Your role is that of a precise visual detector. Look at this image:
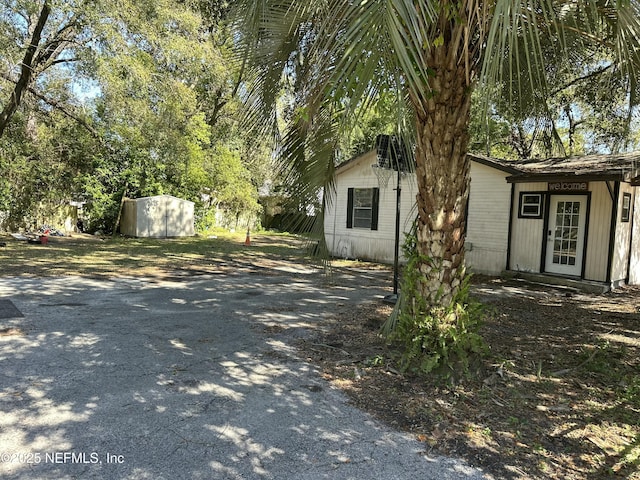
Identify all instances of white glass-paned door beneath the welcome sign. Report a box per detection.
[545,195,587,276]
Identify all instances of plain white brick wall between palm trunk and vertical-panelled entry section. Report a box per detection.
[465,161,511,275]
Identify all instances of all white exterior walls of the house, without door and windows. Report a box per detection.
[324,150,640,284]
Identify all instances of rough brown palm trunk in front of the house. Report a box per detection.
[414,25,471,307]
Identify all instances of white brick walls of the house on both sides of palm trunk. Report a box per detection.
[324,151,511,274]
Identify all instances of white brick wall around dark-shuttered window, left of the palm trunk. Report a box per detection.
[324,150,417,263]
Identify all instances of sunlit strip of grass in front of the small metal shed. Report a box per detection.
[0,231,308,276]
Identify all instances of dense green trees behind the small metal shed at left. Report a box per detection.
[0,0,271,231]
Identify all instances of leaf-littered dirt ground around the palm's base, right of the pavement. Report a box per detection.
[300,278,640,479]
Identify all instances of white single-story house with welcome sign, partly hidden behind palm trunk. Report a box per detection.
[324,146,640,288]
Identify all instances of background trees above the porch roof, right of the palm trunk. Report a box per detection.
[469,61,640,159]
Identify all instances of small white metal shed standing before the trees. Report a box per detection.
[120,195,195,238]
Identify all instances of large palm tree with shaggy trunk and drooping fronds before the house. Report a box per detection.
[233,0,640,378]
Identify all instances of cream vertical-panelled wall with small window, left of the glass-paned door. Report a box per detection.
[509,182,547,273]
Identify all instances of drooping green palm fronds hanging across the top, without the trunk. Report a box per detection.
[234,0,640,240]
